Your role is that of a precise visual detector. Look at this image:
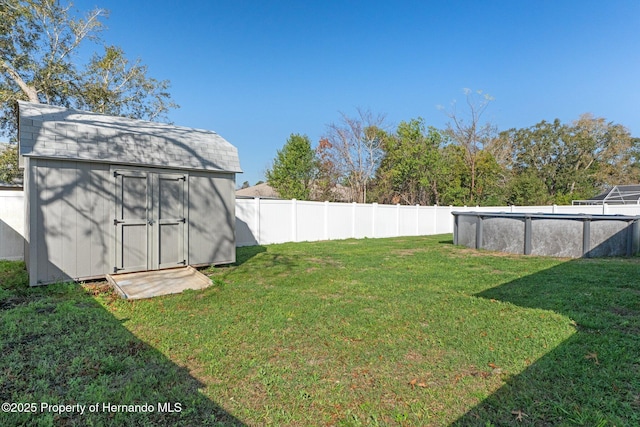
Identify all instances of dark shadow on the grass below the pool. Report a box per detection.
[453,258,640,426]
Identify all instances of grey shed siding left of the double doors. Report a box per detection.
[28,159,113,285]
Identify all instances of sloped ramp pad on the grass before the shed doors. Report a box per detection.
[107,266,211,299]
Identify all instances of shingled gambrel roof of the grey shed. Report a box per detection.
[18,101,242,172]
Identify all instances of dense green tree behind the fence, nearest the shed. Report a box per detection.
[266,134,316,200]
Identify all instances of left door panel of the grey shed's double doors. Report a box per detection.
[114,171,149,272]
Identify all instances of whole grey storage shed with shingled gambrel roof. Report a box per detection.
[19,102,242,286]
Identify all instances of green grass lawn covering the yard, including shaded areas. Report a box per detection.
[0,235,640,426]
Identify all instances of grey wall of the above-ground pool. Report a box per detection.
[452,212,640,258]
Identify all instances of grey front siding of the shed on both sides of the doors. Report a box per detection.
[25,158,235,285]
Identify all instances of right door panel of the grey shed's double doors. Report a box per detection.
[154,174,186,268]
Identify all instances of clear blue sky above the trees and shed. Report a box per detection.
[75,0,640,185]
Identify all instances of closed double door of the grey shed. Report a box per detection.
[113,170,188,273]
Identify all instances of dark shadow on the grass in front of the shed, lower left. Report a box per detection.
[0,261,243,426]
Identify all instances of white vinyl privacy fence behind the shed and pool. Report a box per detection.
[0,191,640,259]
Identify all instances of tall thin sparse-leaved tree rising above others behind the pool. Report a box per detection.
[446,89,497,204]
